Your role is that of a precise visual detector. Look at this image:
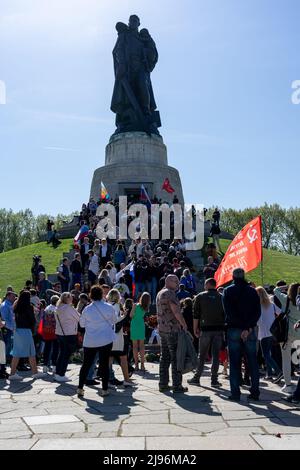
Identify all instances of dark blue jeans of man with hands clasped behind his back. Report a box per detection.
[227,328,259,399]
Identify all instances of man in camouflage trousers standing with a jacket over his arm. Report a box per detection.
[156,274,187,393]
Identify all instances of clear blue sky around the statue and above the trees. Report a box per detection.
[0,0,300,214]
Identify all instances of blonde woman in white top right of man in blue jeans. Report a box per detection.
[256,287,283,382]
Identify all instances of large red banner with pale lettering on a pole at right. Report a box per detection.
[215,216,262,287]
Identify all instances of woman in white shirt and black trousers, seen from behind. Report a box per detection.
[77,286,118,398]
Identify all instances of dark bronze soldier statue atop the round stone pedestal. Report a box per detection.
[111,15,161,135]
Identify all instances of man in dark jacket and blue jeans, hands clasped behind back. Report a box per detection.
[223,268,261,401]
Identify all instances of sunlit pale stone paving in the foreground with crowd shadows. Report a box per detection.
[0,364,300,450]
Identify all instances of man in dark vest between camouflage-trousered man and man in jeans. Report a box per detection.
[188,278,225,387]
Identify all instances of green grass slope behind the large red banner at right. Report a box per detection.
[214,240,300,285]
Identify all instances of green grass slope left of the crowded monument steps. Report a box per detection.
[0,239,72,297]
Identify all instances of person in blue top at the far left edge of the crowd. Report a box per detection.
[0,291,17,378]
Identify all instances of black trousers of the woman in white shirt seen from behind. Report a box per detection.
[79,343,112,390]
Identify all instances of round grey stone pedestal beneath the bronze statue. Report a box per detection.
[91,132,184,204]
